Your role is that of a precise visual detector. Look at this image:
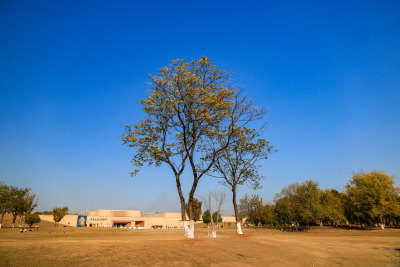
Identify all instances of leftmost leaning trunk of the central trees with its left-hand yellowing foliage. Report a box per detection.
[121,80,188,235]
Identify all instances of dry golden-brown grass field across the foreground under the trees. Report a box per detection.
[0,217,400,266]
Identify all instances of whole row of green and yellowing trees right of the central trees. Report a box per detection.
[239,171,400,229]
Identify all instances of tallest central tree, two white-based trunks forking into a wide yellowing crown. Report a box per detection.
[122,57,259,238]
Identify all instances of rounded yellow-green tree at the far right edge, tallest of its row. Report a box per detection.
[345,170,400,229]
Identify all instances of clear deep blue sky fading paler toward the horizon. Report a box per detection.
[0,1,400,215]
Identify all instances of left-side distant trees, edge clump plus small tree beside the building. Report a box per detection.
[0,181,68,228]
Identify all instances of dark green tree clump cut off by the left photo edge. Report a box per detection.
[0,181,40,228]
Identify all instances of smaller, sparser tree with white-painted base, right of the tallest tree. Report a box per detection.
[211,126,276,234]
